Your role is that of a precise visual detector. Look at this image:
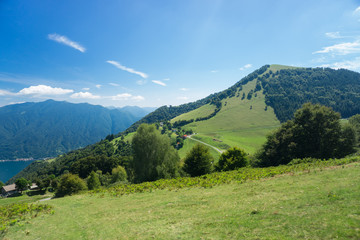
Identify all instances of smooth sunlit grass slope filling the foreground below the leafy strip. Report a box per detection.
[5,163,360,239]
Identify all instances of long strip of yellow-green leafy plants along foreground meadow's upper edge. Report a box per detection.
[90,156,360,196]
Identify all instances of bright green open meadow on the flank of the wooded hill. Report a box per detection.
[177,80,280,153]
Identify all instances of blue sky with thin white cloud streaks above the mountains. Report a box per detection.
[0,0,360,107]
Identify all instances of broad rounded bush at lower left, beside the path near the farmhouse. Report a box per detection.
[55,173,87,197]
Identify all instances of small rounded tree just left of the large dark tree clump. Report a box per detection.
[215,147,248,171]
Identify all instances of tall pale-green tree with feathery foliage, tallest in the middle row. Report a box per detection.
[132,124,179,182]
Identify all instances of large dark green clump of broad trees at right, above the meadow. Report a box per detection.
[258,103,354,166]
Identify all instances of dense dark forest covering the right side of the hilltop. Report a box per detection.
[259,68,360,122]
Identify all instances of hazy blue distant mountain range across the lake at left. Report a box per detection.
[0,100,154,159]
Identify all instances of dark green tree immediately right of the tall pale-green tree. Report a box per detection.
[183,144,213,177]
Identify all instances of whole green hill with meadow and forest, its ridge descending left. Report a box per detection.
[11,65,360,181]
